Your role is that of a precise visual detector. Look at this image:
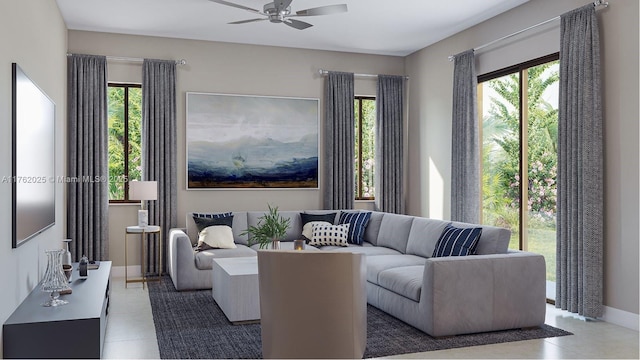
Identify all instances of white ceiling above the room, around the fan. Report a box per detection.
[56,0,528,56]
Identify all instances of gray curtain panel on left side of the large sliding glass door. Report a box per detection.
[451,50,480,223]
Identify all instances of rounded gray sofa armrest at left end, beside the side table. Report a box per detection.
[168,228,196,290]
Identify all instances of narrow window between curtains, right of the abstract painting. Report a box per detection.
[354,96,376,200]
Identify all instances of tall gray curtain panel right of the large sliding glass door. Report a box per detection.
[556,4,604,317]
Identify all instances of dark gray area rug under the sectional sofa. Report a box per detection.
[148,276,572,359]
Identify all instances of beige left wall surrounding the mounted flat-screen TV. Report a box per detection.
[0,0,67,356]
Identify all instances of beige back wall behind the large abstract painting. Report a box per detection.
[68,31,404,266]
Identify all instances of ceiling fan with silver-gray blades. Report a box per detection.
[209,0,347,30]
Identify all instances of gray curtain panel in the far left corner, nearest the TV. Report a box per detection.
[67,55,109,261]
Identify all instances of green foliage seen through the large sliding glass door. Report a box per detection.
[483,62,559,230]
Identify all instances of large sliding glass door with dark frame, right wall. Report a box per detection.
[478,54,559,290]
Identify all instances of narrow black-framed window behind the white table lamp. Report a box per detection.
[107,84,142,202]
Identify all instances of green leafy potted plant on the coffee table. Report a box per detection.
[242,205,290,249]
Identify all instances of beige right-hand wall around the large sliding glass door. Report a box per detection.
[406,0,640,318]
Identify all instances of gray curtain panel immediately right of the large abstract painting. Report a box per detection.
[323,72,355,210]
